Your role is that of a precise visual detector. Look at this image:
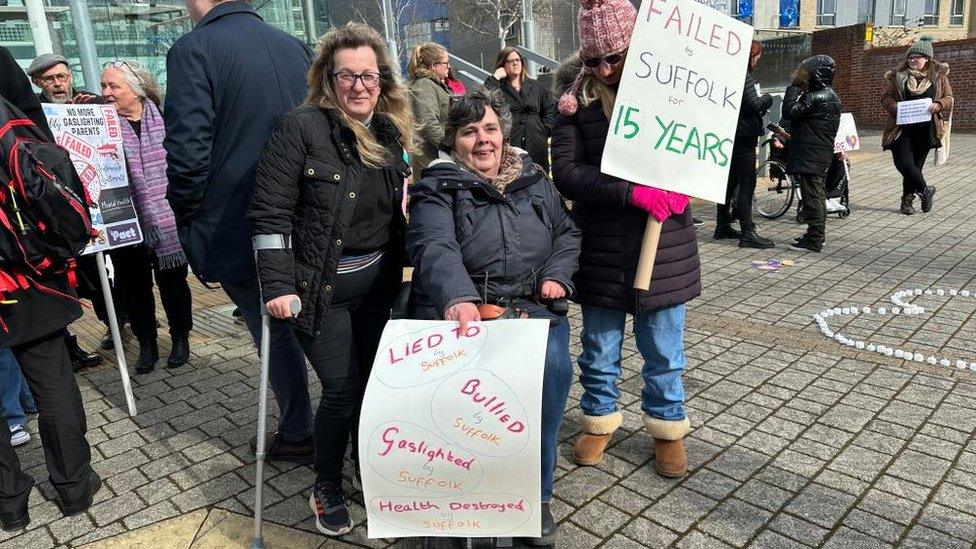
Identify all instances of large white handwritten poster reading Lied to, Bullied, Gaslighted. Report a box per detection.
[359,319,549,538]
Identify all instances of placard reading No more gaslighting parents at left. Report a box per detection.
[43,103,142,254]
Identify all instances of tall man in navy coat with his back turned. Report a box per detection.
[163,0,313,464]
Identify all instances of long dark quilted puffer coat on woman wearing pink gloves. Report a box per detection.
[552,57,701,313]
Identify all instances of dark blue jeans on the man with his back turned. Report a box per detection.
[221,273,312,442]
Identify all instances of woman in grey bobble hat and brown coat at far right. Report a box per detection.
[881,37,954,215]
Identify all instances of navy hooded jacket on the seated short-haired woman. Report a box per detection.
[407,155,580,318]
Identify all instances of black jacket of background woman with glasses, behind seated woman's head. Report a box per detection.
[485,76,556,172]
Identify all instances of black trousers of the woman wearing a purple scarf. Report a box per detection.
[111,246,193,341]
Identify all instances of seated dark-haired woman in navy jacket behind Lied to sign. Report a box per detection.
[407,91,580,545]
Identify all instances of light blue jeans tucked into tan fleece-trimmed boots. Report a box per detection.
[578,305,685,421]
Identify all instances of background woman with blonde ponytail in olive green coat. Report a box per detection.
[407,42,451,175]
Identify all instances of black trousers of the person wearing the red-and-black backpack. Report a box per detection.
[0,330,92,513]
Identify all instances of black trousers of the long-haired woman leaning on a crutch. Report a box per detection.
[295,252,402,484]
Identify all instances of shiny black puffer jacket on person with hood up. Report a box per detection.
[783,55,841,175]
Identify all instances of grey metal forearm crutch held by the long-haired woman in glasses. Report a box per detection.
[251,235,302,549]
